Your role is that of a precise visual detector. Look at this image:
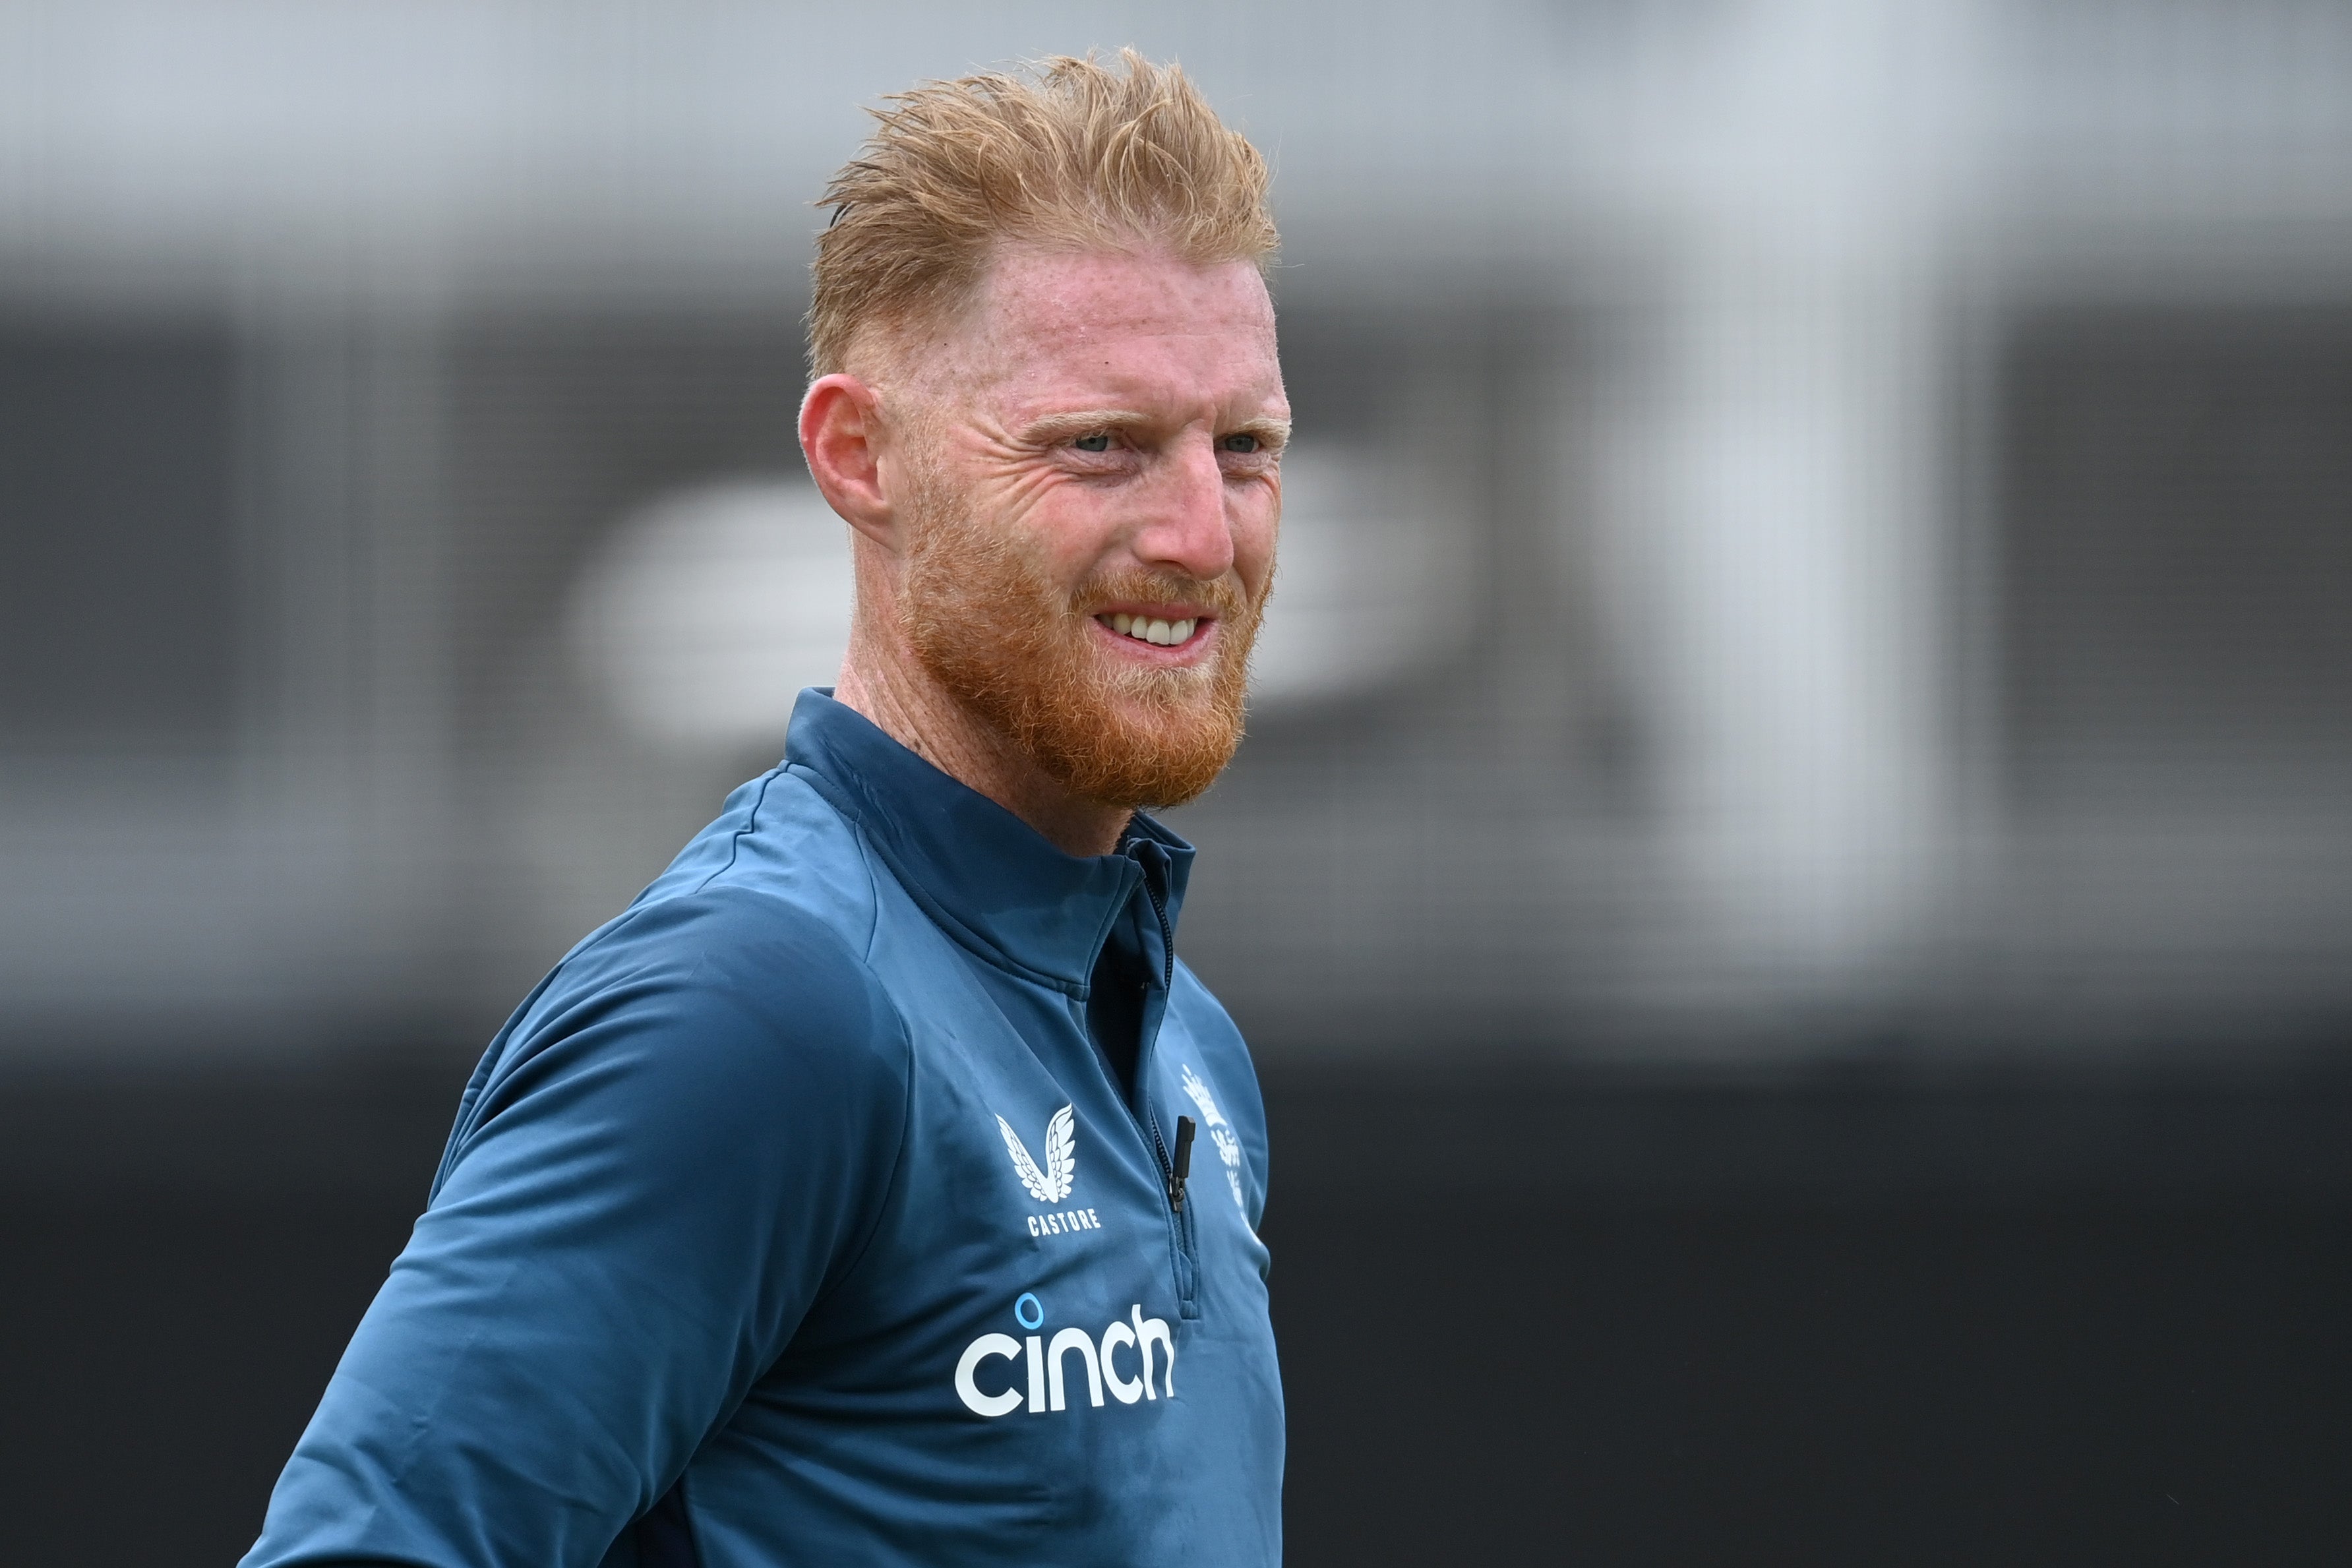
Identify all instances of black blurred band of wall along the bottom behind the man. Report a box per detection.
[0,1053,2352,1568]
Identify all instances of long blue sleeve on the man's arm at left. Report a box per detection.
[245,891,905,1568]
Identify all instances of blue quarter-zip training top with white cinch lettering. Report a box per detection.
[245,689,1282,1568]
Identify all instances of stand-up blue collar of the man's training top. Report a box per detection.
[783,686,1192,997]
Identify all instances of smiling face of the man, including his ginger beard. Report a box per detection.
[901,249,1289,806]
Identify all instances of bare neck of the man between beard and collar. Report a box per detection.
[833,637,1133,856]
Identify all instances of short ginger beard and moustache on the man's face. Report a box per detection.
[899,472,1273,808]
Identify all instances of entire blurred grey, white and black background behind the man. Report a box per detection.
[0,0,2352,1565]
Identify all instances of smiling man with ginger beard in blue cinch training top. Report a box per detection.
[245,54,1289,1568]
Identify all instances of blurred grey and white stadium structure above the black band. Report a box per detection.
[0,0,2352,1056]
